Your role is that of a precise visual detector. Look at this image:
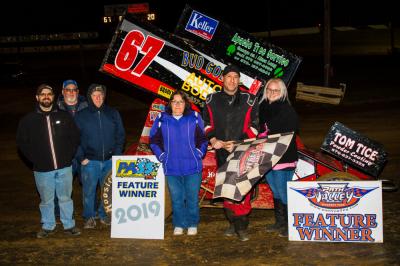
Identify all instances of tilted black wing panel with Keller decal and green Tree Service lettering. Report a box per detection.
[175,5,302,87]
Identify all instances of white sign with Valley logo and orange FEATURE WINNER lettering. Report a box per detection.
[287,181,383,243]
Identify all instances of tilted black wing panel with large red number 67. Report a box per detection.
[100,11,297,107]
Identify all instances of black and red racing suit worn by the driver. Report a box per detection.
[203,89,258,231]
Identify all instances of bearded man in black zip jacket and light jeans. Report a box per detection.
[17,84,80,238]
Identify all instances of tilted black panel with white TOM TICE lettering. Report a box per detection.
[321,122,387,177]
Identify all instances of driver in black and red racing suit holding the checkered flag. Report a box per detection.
[203,65,258,241]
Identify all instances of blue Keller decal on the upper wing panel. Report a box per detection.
[185,10,218,41]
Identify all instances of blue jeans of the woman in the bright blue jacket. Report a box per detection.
[167,173,201,228]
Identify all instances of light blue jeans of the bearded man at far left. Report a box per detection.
[33,166,75,230]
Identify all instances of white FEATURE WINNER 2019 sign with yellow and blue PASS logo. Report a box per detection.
[111,155,165,239]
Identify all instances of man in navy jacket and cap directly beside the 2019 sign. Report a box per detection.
[75,84,125,229]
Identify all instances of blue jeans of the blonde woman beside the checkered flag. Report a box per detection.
[265,170,294,205]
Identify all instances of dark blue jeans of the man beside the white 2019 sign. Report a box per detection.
[81,159,111,220]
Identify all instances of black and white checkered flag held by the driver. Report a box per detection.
[213,132,294,201]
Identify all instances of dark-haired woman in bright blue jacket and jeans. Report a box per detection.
[150,91,208,235]
